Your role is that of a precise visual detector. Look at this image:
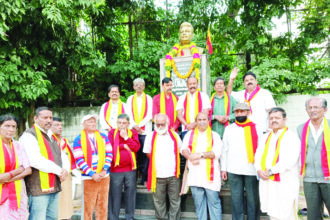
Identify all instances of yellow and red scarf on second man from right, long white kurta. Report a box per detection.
[261,126,288,182]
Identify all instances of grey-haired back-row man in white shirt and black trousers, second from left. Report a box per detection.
[126,78,152,185]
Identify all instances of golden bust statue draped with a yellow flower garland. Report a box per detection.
[165,22,203,81]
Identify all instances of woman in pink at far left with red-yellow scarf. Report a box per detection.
[0,114,32,220]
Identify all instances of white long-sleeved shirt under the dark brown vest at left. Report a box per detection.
[19,124,71,176]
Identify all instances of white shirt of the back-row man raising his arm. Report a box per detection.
[231,89,276,131]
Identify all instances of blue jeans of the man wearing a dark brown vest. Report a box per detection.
[29,192,60,220]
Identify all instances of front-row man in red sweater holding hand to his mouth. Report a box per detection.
[108,114,140,220]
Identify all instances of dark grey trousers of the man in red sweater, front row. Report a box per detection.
[108,170,136,220]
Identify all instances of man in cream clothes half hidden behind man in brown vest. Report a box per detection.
[51,117,76,219]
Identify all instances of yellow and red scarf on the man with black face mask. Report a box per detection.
[235,119,258,163]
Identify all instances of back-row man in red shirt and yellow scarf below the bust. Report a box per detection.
[152,77,180,131]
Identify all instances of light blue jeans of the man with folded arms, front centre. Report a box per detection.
[190,186,222,220]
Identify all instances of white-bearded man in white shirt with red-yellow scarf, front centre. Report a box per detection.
[143,113,182,220]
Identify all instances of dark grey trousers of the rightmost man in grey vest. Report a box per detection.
[304,182,330,220]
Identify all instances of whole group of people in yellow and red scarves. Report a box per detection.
[0,68,330,220]
